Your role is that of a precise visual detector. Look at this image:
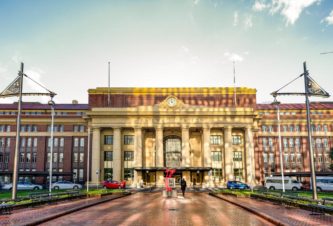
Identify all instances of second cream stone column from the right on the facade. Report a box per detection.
[224,126,234,181]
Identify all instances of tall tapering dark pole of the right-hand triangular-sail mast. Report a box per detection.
[303,62,318,200]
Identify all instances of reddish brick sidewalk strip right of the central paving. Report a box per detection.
[211,192,333,226]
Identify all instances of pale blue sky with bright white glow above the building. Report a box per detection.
[0,0,333,103]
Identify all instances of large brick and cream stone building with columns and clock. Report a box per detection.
[0,88,333,186]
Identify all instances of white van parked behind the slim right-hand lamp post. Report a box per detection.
[265,177,302,191]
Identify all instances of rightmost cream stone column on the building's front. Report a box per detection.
[245,126,255,184]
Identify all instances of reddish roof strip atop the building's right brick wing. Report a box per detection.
[257,102,333,110]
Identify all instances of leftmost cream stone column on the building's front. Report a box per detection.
[91,128,101,184]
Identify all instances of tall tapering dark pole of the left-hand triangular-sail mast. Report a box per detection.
[12,63,24,200]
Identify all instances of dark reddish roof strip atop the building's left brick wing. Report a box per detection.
[0,102,89,110]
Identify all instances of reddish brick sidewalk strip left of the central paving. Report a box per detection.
[0,194,128,226]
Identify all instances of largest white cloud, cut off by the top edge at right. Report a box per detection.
[252,0,321,26]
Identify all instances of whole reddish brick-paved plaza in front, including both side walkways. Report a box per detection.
[0,192,333,226]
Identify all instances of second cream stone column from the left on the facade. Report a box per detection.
[113,128,122,181]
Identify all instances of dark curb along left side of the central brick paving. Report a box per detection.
[18,193,131,226]
